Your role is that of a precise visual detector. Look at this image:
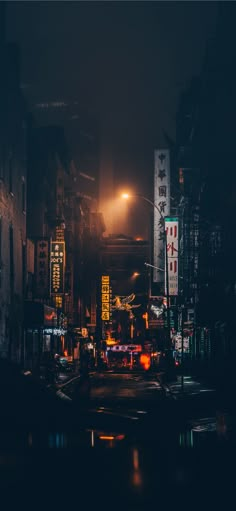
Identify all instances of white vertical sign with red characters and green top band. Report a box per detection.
[165,217,179,296]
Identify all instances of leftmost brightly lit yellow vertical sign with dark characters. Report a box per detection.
[50,241,65,294]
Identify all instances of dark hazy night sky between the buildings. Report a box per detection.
[7,1,218,234]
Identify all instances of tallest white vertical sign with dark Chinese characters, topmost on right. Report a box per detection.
[153,149,170,283]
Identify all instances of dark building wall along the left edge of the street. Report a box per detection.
[0,6,28,362]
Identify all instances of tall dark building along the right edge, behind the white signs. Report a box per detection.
[176,2,236,372]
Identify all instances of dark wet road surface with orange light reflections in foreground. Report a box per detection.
[0,373,235,511]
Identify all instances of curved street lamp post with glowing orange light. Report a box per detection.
[122,193,171,350]
